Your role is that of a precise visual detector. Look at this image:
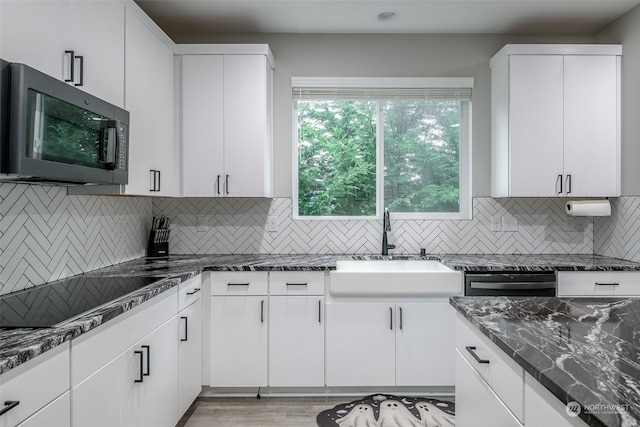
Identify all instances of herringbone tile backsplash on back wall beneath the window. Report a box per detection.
[153,198,593,254]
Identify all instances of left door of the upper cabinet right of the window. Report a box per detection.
[508,55,563,197]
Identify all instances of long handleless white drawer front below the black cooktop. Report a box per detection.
[71,286,178,387]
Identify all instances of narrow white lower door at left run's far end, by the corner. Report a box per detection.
[178,299,202,417]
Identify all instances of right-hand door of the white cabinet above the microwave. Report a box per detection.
[70,0,125,107]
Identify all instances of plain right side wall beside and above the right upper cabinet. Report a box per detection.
[595,6,640,196]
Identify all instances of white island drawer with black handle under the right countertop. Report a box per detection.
[456,313,524,422]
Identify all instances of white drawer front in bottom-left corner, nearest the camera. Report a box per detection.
[0,342,70,426]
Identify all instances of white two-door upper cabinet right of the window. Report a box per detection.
[491,45,622,197]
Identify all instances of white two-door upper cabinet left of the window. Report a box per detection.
[178,45,273,197]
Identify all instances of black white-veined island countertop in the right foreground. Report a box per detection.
[450,297,640,427]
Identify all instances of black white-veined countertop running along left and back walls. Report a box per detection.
[0,255,640,374]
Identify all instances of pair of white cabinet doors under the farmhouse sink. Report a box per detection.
[326,299,455,387]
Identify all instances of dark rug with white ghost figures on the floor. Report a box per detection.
[316,394,456,427]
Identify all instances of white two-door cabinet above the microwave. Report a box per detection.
[0,0,125,107]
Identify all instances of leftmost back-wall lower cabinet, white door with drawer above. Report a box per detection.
[209,272,269,387]
